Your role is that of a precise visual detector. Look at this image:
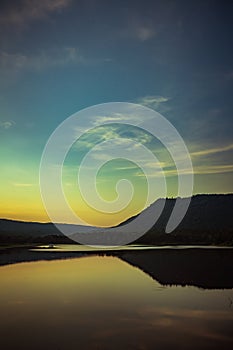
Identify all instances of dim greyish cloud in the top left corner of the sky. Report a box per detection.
[0,0,72,26]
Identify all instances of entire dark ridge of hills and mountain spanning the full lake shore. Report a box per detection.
[0,194,233,245]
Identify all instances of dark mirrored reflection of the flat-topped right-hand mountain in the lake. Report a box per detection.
[117,248,233,289]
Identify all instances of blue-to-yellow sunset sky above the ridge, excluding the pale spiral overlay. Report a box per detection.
[0,0,233,226]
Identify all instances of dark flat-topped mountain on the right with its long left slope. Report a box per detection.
[68,194,233,246]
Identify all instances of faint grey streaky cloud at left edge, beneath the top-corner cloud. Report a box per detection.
[0,47,83,74]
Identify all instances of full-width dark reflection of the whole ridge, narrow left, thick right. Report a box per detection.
[0,248,233,289]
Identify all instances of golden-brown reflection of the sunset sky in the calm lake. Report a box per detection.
[0,256,233,350]
